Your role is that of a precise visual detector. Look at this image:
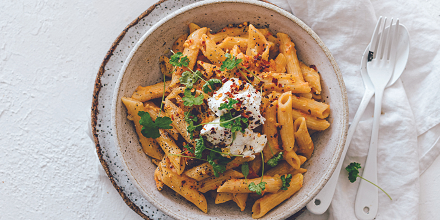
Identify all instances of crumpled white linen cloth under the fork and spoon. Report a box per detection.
[270,0,440,219]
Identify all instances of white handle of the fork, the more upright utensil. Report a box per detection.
[354,89,383,220]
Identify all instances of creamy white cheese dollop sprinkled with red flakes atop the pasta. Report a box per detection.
[200,78,267,156]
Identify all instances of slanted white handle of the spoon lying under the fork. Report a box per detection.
[307,90,374,215]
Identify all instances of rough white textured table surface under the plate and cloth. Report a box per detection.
[0,0,440,220]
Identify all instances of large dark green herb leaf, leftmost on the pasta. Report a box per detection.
[138,111,173,139]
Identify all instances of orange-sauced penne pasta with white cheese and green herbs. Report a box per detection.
[122,22,330,218]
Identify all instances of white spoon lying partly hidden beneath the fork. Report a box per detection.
[307,24,409,215]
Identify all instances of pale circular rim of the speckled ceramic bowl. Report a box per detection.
[111,0,348,219]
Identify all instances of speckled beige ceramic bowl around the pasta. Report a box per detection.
[112,1,348,219]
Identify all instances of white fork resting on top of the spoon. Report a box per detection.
[355,17,399,219]
